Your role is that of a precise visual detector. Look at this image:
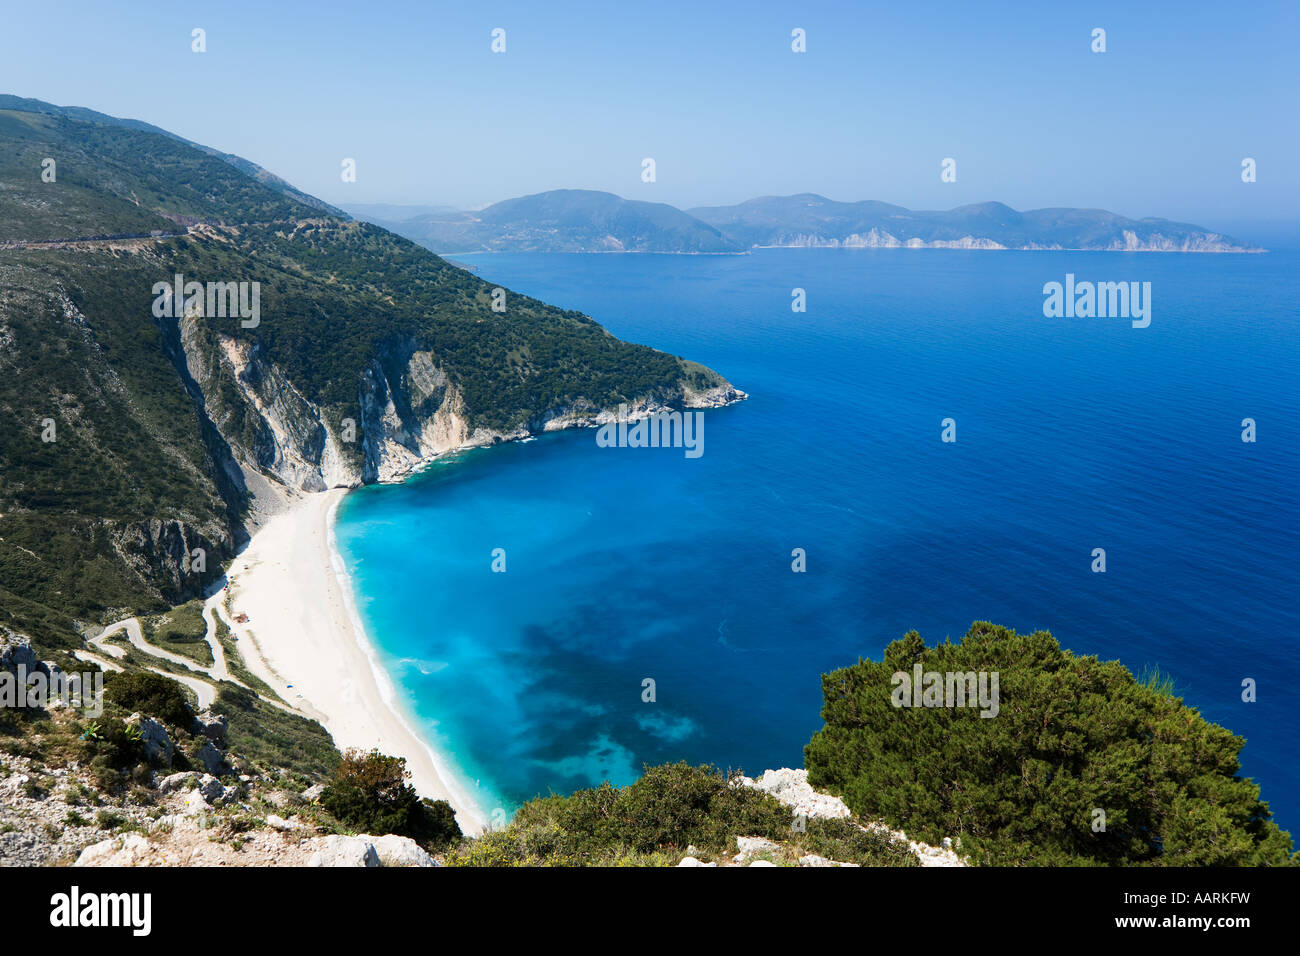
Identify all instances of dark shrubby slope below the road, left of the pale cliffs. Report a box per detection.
[0,251,234,644]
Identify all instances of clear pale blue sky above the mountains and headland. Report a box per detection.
[0,0,1300,230]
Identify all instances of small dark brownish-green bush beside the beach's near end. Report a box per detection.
[321,750,460,848]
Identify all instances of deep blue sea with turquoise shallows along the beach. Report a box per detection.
[337,250,1300,835]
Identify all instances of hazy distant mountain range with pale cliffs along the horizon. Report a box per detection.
[348,190,1264,254]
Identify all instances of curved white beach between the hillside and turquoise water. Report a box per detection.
[216,488,488,834]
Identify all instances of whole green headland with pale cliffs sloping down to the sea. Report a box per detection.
[0,111,742,658]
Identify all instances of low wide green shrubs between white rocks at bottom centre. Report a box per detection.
[446,762,917,866]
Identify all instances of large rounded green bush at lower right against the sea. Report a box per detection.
[805,622,1296,866]
